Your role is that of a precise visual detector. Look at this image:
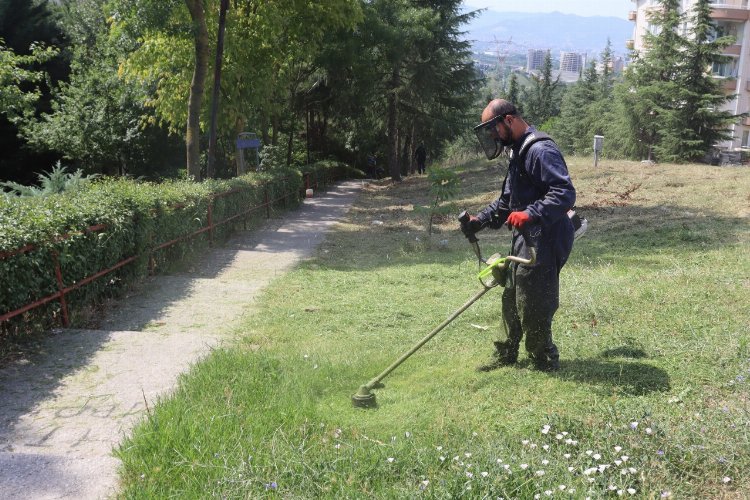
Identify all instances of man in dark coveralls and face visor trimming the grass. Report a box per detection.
[461,99,576,371]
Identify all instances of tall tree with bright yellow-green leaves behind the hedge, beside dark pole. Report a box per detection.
[113,0,360,180]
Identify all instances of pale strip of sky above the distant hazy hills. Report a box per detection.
[464,0,635,19]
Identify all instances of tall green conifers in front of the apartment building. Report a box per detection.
[618,0,736,162]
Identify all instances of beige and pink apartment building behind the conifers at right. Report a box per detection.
[627,0,750,150]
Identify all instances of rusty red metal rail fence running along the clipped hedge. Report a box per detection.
[0,174,328,327]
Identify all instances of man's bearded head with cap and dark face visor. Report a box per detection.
[474,99,528,160]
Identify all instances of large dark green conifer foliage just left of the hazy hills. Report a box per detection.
[310,0,479,177]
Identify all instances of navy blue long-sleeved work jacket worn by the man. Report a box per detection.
[477,127,576,272]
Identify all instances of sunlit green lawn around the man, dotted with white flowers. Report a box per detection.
[117,159,750,499]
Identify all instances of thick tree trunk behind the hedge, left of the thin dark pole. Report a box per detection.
[185,0,208,180]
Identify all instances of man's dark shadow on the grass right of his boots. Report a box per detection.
[552,358,670,396]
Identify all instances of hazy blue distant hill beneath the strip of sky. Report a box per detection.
[465,10,634,57]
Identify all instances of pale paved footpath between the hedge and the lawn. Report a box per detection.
[0,181,363,499]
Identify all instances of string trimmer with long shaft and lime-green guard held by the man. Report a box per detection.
[352,212,536,408]
